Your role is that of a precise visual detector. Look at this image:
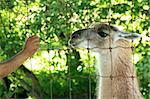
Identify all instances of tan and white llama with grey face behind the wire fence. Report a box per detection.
[69,23,143,99]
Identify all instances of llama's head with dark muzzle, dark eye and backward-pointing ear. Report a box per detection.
[69,23,140,52]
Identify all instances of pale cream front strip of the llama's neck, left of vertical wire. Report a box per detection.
[96,53,111,99]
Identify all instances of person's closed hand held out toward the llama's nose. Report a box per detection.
[23,36,40,57]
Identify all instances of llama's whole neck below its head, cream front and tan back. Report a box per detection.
[96,48,141,99]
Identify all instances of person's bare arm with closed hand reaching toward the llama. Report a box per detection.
[0,36,40,78]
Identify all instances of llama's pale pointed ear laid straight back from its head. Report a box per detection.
[118,32,141,40]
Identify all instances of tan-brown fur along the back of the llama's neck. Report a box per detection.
[112,40,142,99]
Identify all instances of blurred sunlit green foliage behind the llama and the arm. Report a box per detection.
[0,0,150,99]
